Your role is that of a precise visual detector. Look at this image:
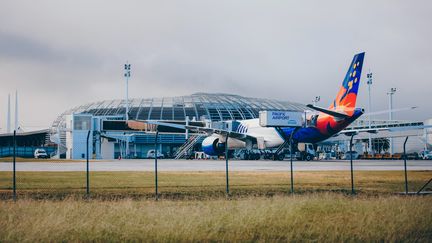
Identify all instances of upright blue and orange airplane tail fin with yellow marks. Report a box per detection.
[329,52,365,113]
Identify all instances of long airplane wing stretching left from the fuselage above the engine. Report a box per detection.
[128,121,257,142]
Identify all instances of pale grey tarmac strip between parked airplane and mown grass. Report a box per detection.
[0,159,432,174]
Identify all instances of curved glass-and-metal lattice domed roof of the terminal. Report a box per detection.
[51,93,306,130]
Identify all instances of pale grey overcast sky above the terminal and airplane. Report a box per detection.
[0,0,432,131]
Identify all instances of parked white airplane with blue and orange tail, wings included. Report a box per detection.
[128,52,428,156]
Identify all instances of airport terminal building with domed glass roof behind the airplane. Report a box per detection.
[46,93,423,159]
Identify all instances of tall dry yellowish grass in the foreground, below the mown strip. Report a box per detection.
[0,193,432,242]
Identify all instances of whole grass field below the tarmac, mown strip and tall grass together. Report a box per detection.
[0,171,432,242]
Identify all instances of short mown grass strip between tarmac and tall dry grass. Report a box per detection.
[0,171,432,200]
